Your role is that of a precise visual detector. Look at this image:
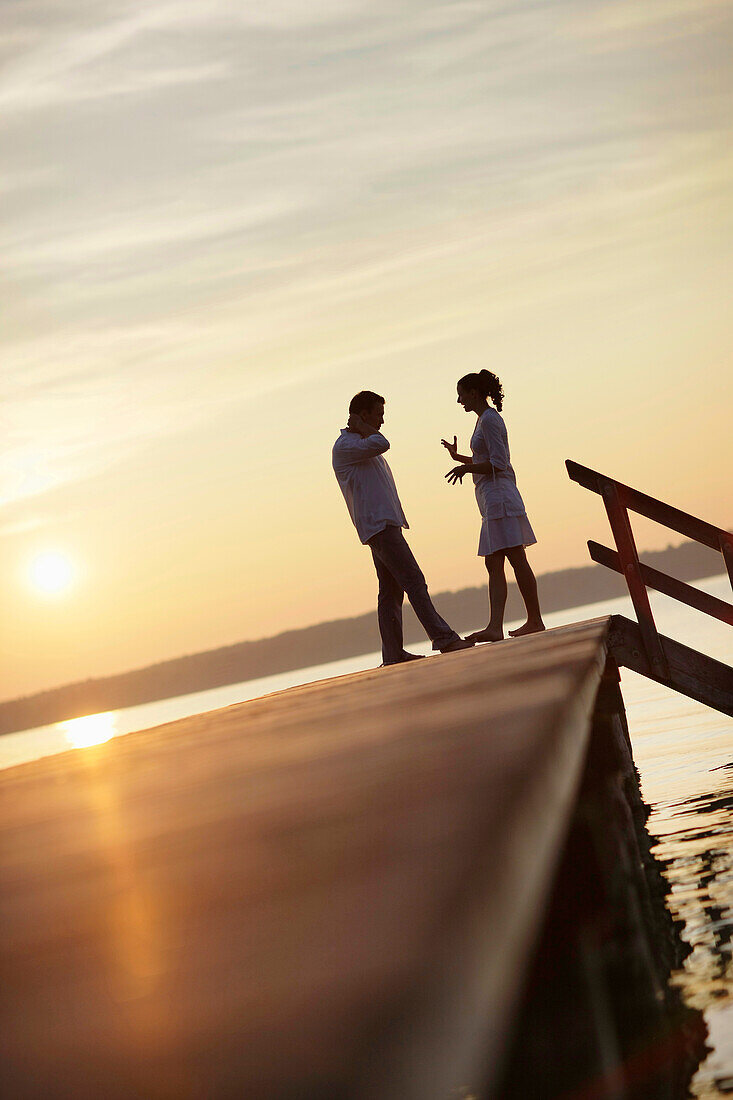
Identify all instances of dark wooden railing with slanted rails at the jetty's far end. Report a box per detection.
[566,459,733,682]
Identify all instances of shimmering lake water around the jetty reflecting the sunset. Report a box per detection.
[0,576,733,1100]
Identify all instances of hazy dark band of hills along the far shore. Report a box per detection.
[0,542,722,735]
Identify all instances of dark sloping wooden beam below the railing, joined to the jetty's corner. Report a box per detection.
[609,615,733,716]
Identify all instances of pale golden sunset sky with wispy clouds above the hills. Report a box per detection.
[0,0,733,699]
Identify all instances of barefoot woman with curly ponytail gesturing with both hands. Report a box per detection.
[440,371,545,641]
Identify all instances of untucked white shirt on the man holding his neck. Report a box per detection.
[332,428,409,542]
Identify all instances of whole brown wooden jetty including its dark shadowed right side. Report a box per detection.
[0,468,733,1100]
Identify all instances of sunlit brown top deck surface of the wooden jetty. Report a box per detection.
[0,618,609,1100]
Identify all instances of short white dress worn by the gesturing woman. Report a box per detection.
[471,408,537,558]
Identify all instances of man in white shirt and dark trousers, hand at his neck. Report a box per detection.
[333,389,473,664]
